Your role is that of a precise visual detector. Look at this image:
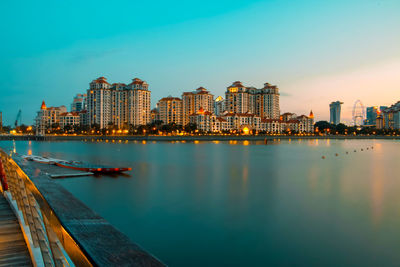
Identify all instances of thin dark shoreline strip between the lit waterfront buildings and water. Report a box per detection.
[0,135,400,142]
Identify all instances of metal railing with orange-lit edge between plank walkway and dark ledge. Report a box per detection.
[0,149,92,266]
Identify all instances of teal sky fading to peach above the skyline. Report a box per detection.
[0,0,400,125]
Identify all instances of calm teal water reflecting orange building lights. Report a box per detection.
[0,140,400,266]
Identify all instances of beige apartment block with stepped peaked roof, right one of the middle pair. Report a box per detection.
[182,87,214,125]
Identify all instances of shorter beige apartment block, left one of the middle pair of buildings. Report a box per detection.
[157,96,183,125]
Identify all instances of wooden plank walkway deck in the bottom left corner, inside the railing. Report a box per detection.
[0,194,32,267]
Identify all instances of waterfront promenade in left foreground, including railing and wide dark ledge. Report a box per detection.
[0,150,164,266]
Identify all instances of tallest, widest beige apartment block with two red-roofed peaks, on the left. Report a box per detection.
[86,77,151,128]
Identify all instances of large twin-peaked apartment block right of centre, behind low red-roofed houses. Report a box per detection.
[225,81,280,119]
